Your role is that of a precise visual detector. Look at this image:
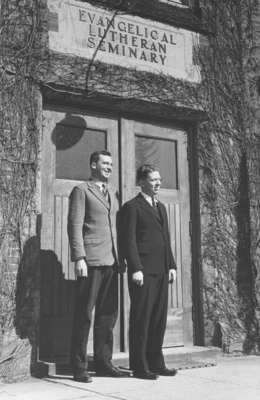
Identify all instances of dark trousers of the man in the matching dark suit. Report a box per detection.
[128,273,168,372]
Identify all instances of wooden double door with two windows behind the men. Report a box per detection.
[39,108,193,363]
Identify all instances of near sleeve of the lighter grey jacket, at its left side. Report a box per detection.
[68,187,86,261]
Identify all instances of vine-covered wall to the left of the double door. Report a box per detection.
[0,1,44,381]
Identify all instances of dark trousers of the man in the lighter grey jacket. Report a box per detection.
[71,266,118,373]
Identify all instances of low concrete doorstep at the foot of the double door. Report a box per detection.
[44,346,221,376]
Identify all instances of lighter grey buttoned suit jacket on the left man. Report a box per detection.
[68,180,119,267]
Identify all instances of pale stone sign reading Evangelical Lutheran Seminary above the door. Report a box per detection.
[48,0,200,82]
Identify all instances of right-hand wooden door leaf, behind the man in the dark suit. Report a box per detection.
[121,119,192,347]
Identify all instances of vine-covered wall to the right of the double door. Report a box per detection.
[199,0,259,353]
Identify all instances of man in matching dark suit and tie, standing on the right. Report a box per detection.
[121,164,177,379]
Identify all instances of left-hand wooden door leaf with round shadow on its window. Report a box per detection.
[40,109,120,363]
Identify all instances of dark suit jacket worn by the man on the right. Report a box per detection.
[120,193,176,274]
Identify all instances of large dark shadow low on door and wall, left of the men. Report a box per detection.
[12,236,75,377]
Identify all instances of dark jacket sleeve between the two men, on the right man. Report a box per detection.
[120,203,143,273]
